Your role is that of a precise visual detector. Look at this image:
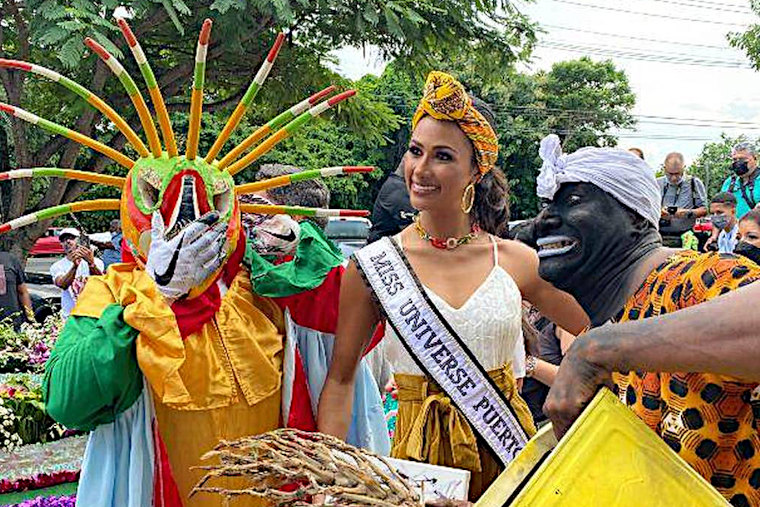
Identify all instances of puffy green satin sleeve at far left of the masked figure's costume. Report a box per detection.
[42,304,143,431]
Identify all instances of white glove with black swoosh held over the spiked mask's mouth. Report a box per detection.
[145,211,227,301]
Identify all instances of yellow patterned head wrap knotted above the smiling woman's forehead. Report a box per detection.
[412,71,499,175]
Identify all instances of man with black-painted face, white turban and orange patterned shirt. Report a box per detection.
[535,136,760,505]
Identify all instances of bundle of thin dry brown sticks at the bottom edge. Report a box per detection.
[190,429,423,507]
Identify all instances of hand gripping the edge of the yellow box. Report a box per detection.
[544,331,612,439]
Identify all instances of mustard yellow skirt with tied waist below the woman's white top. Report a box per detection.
[391,364,536,501]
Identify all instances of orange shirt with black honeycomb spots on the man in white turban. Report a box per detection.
[615,251,760,506]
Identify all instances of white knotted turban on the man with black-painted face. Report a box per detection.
[536,134,661,227]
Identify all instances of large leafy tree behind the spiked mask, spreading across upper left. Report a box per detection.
[0,0,534,256]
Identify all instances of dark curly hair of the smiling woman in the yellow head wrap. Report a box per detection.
[470,95,509,237]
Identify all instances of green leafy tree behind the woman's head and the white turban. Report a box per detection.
[366,56,635,218]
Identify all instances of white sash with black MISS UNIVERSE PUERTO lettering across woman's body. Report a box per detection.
[354,237,528,465]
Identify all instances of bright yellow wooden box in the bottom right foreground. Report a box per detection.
[476,389,728,507]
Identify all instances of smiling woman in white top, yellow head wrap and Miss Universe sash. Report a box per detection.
[317,72,588,499]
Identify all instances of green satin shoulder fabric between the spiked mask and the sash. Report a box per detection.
[243,221,343,298]
